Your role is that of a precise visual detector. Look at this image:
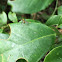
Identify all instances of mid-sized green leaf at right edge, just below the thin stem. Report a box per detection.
[46,15,62,25]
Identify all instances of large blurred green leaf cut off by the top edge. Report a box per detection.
[8,0,53,13]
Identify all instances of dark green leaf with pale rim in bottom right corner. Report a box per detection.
[44,46,62,62]
